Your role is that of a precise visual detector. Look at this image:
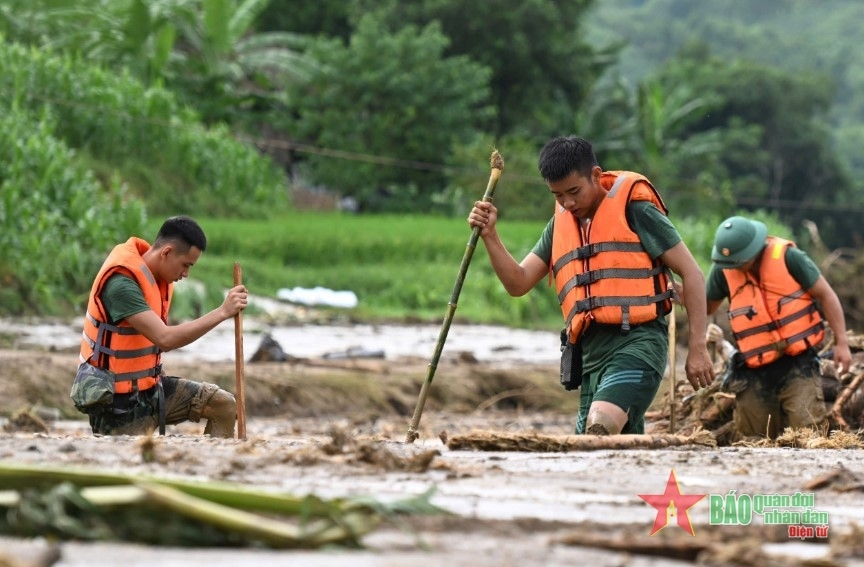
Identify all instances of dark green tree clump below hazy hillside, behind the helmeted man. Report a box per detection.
[661,46,861,245]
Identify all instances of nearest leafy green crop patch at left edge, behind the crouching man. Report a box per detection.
[0,107,144,315]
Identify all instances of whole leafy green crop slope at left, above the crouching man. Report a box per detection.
[0,38,287,313]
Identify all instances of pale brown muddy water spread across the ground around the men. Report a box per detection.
[0,320,864,567]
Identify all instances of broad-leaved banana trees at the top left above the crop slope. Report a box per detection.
[0,0,315,124]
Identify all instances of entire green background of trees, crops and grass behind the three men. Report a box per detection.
[0,0,864,324]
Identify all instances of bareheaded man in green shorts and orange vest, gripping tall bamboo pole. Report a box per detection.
[468,136,714,435]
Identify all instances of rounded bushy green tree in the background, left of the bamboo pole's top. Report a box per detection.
[280,15,490,211]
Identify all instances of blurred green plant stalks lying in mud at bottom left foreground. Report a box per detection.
[0,464,445,549]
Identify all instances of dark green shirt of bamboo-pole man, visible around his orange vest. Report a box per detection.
[532,201,681,376]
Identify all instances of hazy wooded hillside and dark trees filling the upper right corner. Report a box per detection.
[585,0,864,246]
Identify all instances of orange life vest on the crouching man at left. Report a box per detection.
[80,237,174,394]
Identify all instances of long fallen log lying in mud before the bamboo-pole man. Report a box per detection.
[447,429,717,453]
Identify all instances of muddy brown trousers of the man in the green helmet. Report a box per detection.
[734,352,828,439]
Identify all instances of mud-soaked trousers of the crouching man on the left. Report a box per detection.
[90,376,219,435]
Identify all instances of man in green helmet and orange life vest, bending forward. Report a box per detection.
[706,216,852,438]
